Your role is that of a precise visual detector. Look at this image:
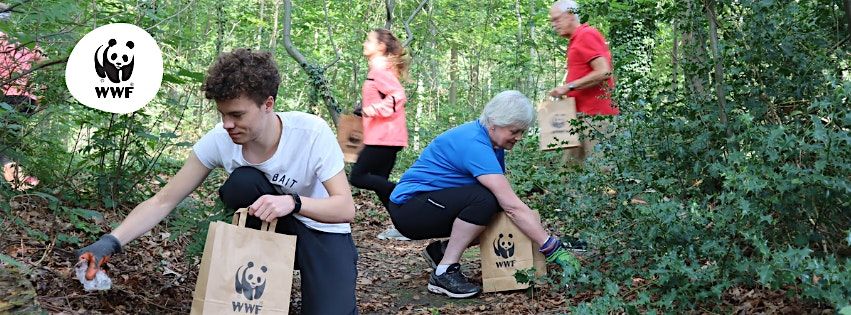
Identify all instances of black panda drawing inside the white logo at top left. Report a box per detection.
[95,39,135,83]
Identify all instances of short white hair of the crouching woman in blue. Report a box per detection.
[479,90,535,129]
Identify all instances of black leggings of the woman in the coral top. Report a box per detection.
[349,145,402,208]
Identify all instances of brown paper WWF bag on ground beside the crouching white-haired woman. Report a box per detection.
[479,212,547,292]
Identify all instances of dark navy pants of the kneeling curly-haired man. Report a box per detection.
[219,166,358,314]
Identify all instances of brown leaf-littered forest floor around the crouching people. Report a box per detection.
[0,189,840,314]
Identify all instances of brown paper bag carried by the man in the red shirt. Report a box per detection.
[538,97,580,150]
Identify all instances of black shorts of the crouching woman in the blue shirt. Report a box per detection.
[390,184,502,240]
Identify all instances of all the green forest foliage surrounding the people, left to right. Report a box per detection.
[0,0,851,314]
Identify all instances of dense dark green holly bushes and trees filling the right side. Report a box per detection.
[509,1,851,313]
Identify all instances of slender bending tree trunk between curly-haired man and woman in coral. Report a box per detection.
[284,0,340,127]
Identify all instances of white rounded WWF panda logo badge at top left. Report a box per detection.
[65,23,163,114]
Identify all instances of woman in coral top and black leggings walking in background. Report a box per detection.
[349,29,409,237]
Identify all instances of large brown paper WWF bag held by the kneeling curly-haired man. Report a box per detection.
[191,208,296,315]
